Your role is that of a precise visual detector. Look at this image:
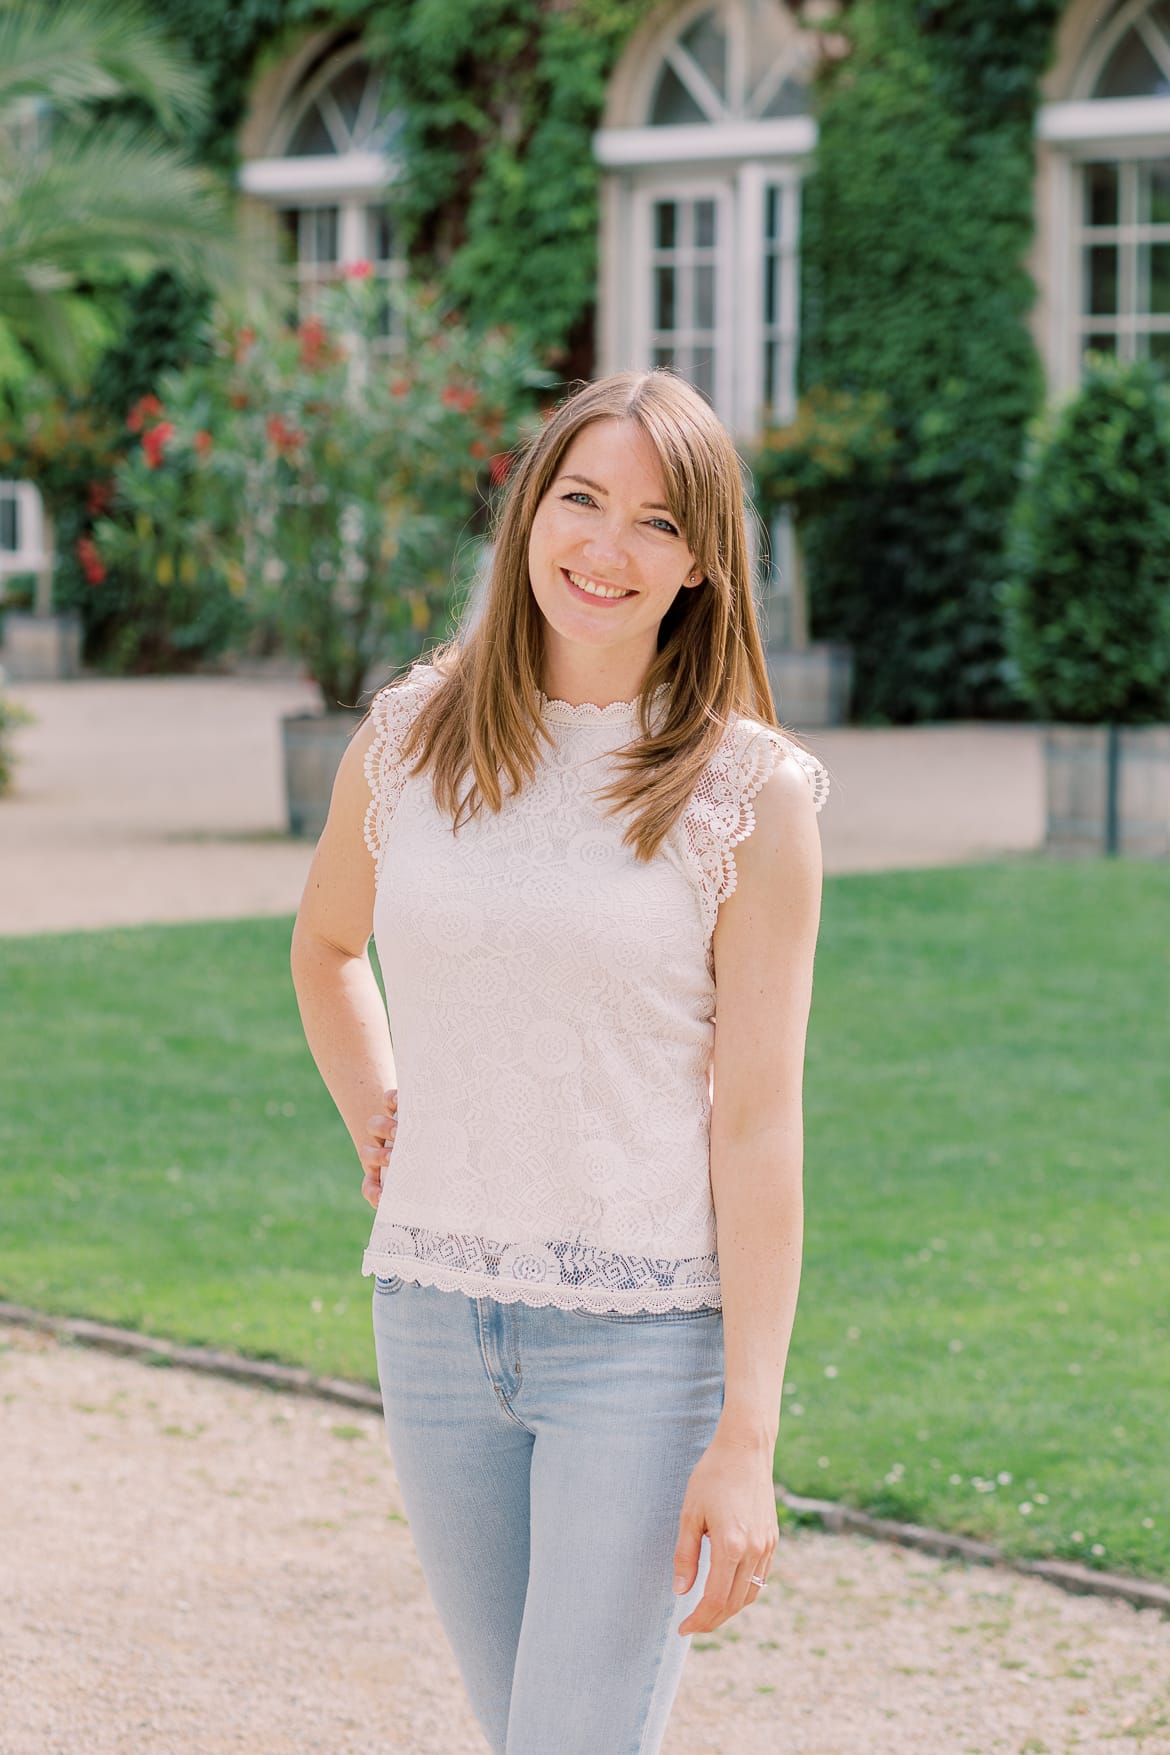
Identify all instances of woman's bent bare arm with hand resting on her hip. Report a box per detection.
[291,721,398,1206]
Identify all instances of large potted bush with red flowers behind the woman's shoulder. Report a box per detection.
[98,265,544,711]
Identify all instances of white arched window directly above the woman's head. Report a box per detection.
[595,0,817,437]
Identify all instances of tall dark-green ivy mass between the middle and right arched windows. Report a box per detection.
[800,0,1061,723]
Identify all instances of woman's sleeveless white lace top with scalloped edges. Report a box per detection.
[363,665,828,1311]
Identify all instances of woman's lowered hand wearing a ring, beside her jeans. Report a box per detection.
[674,1434,779,1634]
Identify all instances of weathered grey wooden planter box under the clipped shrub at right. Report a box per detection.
[1044,725,1170,858]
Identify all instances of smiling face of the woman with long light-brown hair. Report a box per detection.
[528,419,702,693]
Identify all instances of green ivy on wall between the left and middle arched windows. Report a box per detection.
[156,0,653,376]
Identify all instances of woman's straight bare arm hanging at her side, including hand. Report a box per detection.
[675,760,821,1636]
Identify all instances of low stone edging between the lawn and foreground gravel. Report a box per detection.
[0,1300,1170,1615]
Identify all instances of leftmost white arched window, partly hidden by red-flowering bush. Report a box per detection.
[240,44,403,333]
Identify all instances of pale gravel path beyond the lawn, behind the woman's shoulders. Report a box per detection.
[0,676,1044,934]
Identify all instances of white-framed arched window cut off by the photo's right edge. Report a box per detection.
[1038,0,1170,388]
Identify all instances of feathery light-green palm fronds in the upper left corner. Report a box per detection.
[0,0,240,390]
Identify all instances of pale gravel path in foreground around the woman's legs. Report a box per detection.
[0,1329,1170,1755]
